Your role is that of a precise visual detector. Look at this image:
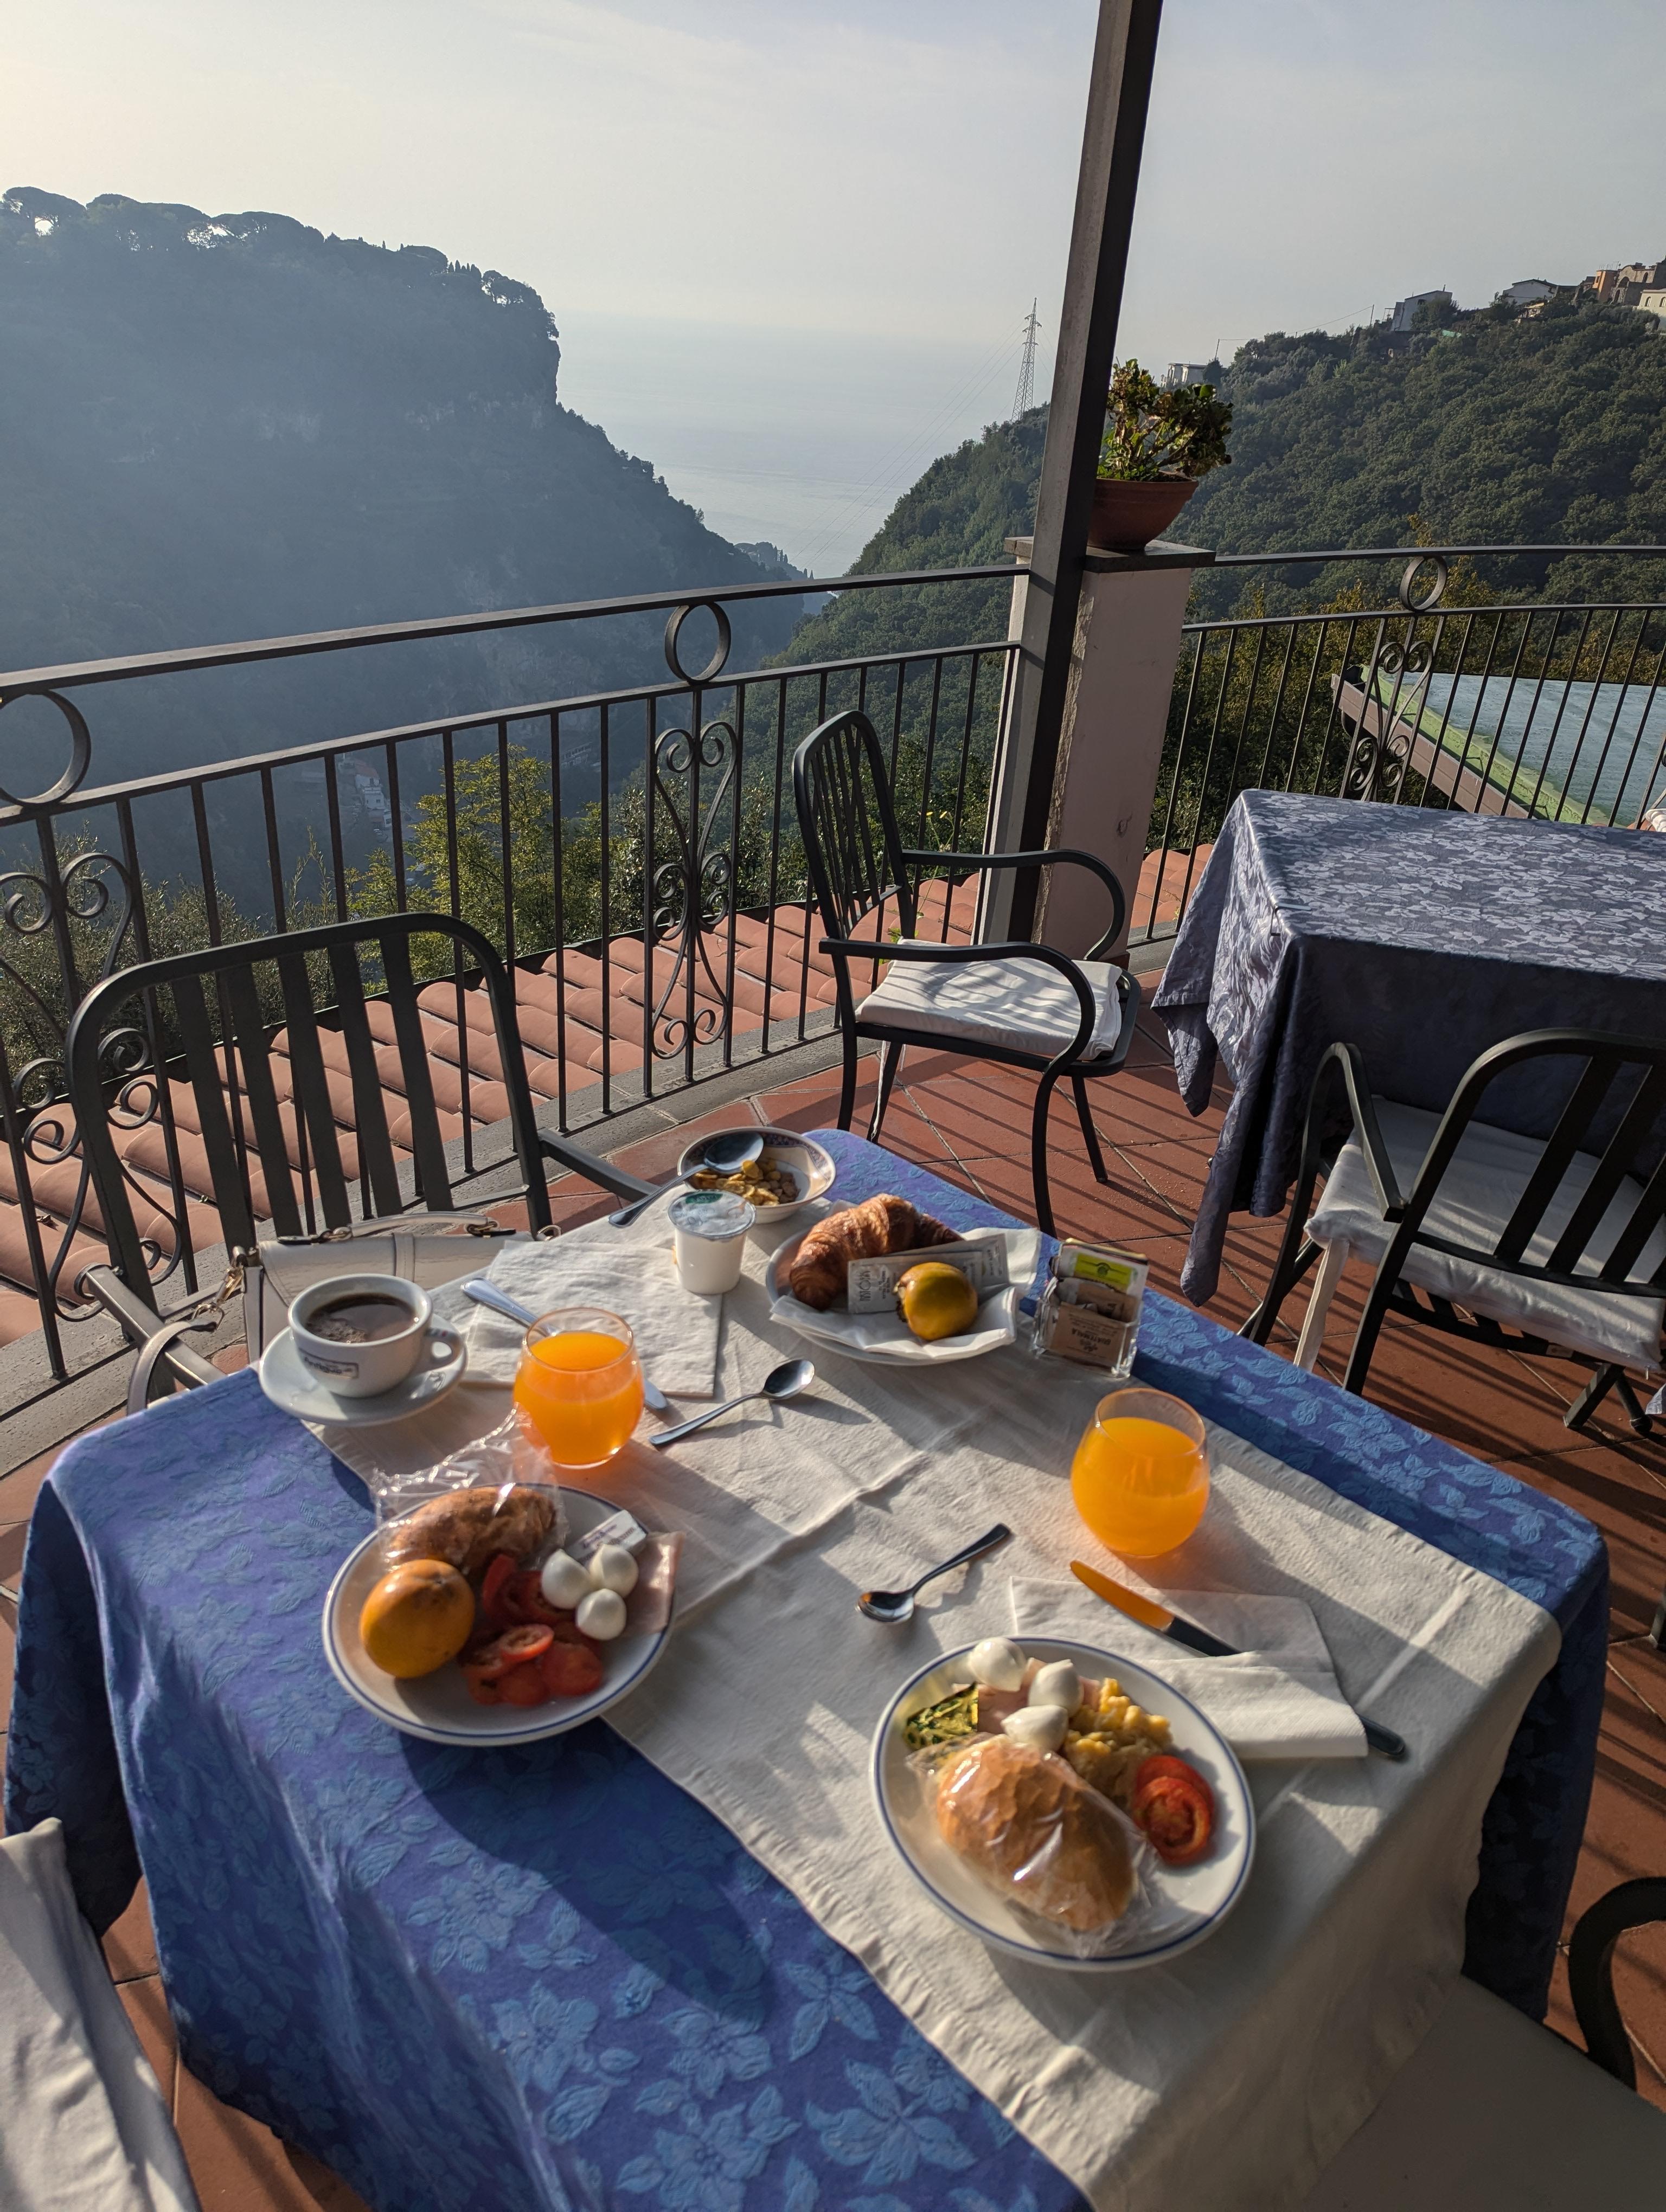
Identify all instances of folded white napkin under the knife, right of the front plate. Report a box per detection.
[1009,1577,1365,1759]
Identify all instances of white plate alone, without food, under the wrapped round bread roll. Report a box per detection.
[872,1637,1254,1973]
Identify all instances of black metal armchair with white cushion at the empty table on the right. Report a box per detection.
[1241,1028,1666,1436]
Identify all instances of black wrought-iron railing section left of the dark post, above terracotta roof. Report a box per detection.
[0,564,1013,1378]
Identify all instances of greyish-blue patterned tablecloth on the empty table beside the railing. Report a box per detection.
[1153,792,1666,1305]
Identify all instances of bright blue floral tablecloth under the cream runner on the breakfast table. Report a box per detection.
[7,1130,1606,2212]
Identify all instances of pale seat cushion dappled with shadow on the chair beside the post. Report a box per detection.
[856,938,1122,1059]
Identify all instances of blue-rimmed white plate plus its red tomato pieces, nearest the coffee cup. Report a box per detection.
[323,1489,670,1745]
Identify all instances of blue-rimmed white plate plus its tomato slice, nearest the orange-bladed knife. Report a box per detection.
[869,1635,1254,1973]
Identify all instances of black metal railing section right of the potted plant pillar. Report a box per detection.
[1135,546,1666,940]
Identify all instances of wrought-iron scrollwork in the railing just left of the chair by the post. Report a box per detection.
[648,721,741,1059]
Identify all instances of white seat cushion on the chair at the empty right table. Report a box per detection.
[1308,1099,1666,1367]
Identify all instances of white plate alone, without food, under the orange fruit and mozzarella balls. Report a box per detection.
[323,1489,670,1745]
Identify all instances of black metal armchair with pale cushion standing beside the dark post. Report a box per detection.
[792,710,1139,1234]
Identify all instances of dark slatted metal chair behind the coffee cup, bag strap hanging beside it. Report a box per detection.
[66,914,650,1385]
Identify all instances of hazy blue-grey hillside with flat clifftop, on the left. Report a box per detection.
[0,188,792,796]
